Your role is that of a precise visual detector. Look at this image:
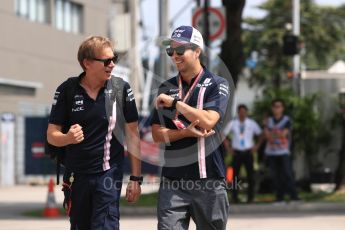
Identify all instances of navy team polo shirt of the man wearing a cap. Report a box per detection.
[151,68,230,180]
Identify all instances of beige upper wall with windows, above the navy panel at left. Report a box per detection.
[0,0,124,115]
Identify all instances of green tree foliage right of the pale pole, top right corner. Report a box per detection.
[301,3,345,69]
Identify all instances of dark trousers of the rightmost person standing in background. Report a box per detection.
[267,154,298,201]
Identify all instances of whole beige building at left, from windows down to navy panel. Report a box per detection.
[0,0,134,186]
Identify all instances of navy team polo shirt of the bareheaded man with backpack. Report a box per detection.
[49,74,138,174]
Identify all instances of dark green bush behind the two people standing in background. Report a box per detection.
[253,89,330,156]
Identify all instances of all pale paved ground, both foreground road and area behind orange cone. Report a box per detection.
[0,186,345,230]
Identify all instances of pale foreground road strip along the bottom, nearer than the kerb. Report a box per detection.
[0,215,345,230]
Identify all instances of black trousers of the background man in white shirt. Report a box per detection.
[232,150,254,202]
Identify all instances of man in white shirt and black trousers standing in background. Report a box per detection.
[223,104,263,203]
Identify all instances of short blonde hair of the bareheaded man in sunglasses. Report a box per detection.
[78,36,115,70]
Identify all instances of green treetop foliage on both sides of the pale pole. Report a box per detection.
[242,0,345,88]
